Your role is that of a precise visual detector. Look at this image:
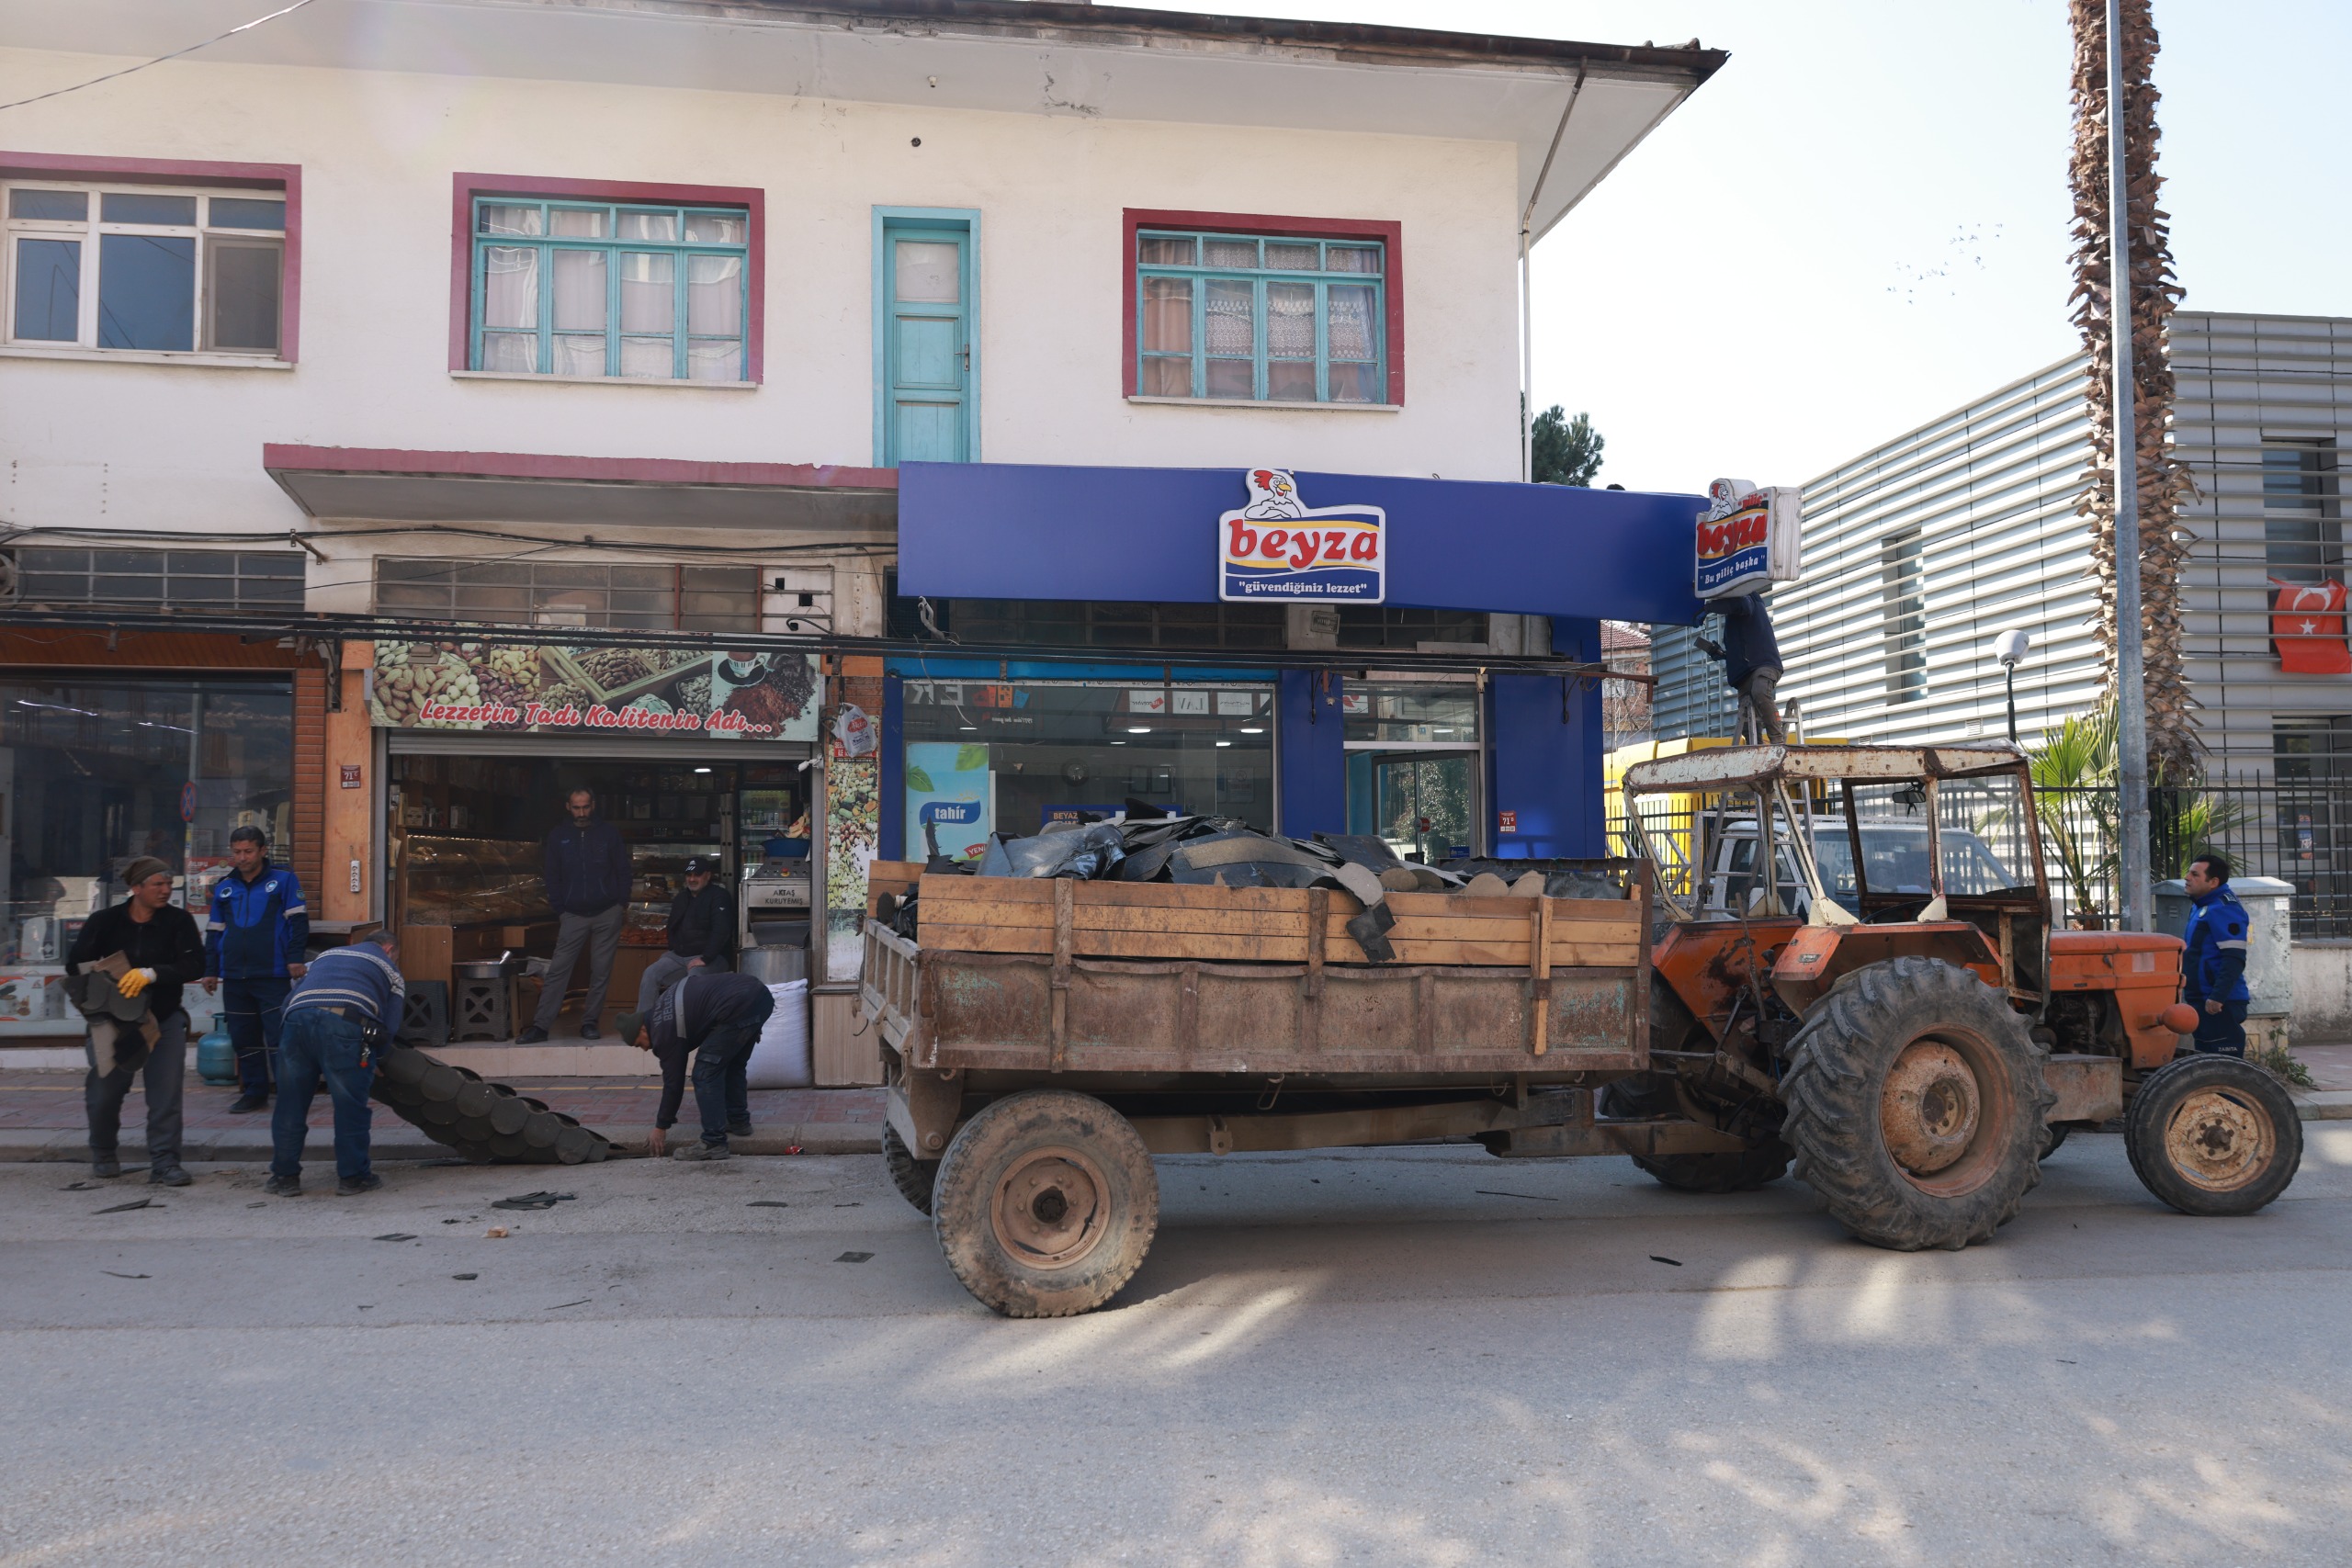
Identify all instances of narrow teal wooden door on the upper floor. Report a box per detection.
[882,226,974,466]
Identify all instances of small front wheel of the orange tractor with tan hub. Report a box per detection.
[2124,1055,2302,1215]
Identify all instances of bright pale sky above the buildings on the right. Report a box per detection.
[1105,0,2352,489]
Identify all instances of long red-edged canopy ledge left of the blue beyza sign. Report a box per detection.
[261,445,899,546]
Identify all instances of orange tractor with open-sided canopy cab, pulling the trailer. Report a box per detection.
[1600,743,2302,1251]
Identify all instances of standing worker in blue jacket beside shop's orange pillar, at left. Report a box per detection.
[205,828,311,1112]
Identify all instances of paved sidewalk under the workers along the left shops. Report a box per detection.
[0,1069,882,1164]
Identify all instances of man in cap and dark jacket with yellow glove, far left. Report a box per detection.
[66,856,205,1187]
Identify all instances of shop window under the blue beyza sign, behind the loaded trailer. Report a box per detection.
[903,680,1275,861]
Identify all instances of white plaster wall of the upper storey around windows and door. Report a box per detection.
[0,50,1517,545]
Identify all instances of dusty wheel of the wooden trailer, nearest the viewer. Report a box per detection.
[932,1089,1159,1316]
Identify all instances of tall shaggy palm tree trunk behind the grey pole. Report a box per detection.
[2067,0,2197,778]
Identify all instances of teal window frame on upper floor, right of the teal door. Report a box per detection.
[1131,228,1390,407]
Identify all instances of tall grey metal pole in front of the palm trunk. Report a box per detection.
[2108,0,2150,931]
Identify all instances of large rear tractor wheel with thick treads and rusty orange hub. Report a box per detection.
[1781,957,2053,1253]
